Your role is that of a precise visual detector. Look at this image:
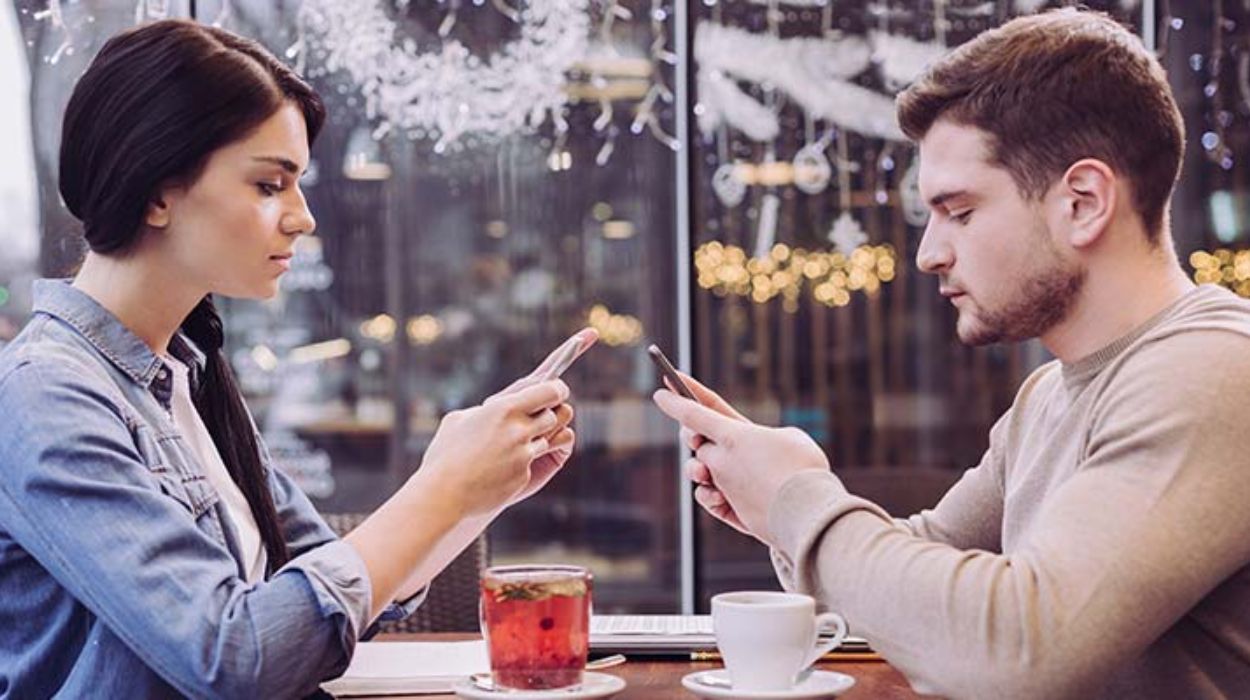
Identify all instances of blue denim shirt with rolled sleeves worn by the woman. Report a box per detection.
[0,280,423,699]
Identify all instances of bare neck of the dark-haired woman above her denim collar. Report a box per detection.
[74,253,205,355]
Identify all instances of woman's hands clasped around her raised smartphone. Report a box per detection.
[418,380,574,518]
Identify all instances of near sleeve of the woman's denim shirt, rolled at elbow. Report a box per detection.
[0,361,371,698]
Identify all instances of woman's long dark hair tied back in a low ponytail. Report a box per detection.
[60,20,325,571]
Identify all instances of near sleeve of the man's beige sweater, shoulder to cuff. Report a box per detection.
[770,331,1250,699]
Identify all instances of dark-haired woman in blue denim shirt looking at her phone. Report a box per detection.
[0,21,594,698]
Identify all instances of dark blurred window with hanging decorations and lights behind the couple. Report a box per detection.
[0,0,1250,613]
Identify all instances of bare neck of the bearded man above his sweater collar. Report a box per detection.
[1041,241,1194,364]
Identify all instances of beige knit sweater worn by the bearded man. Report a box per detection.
[769,286,1250,699]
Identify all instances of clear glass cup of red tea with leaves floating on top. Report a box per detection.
[481,565,593,690]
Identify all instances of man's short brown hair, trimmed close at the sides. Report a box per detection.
[898,9,1185,243]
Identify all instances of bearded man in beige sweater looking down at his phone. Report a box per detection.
[655,10,1250,699]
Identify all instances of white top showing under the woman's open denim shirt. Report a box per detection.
[163,355,269,584]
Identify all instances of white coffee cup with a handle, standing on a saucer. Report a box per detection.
[711,591,846,691]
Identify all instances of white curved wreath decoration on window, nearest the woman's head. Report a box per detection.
[302,0,590,153]
